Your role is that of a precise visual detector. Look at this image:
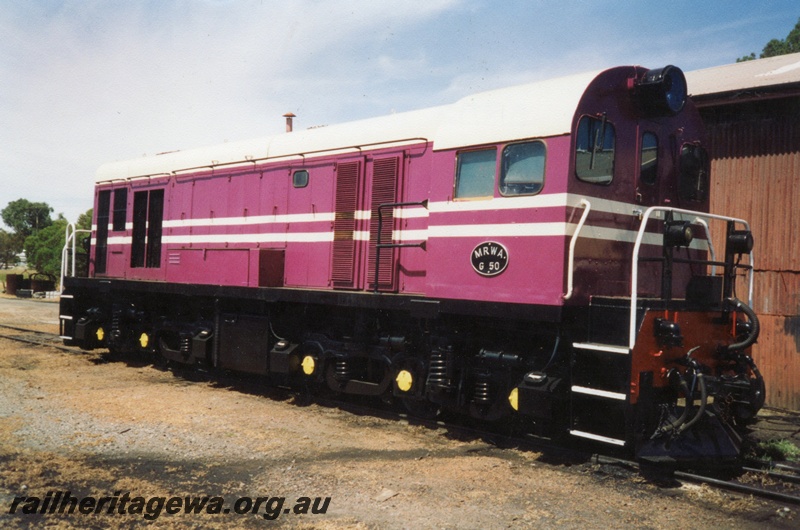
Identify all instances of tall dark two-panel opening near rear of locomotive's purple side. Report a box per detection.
[131,190,164,268]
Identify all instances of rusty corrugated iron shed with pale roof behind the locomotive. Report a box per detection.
[686,53,800,410]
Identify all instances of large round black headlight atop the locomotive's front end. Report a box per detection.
[634,65,688,116]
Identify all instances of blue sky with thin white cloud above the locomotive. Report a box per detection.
[0,0,800,222]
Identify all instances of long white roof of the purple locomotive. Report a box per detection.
[96,72,598,183]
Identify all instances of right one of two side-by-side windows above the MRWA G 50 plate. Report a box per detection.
[500,141,546,195]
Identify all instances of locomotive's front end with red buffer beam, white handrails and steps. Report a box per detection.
[568,66,763,465]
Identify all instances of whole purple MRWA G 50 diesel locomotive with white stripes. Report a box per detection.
[60,66,764,466]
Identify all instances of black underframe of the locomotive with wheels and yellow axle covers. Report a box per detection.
[61,278,758,463]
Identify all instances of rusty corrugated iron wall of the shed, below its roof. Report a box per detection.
[703,98,800,410]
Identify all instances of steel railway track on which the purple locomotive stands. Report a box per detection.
[0,324,800,506]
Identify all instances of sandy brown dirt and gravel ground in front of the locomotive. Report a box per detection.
[0,298,800,529]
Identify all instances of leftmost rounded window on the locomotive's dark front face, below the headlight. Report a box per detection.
[575,115,616,184]
